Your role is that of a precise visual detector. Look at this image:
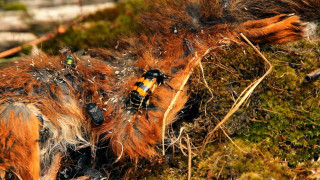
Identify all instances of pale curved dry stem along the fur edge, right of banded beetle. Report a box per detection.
[162,48,216,155]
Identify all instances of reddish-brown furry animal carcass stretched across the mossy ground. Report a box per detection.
[0,0,320,179]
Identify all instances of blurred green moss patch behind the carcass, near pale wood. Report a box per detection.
[41,0,143,54]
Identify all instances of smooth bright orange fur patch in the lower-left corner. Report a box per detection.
[0,103,40,179]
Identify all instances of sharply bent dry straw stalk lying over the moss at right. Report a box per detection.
[200,33,272,154]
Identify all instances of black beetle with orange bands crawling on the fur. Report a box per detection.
[129,69,173,119]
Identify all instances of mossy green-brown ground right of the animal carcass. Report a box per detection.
[183,35,320,179]
